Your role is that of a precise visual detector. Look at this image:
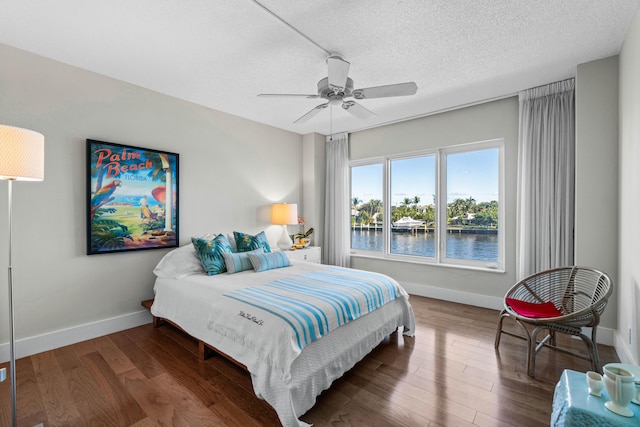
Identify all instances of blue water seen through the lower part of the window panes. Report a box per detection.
[351,229,498,262]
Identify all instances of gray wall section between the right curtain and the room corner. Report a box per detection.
[575,56,618,334]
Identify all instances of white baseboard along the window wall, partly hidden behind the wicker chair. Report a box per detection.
[401,282,618,351]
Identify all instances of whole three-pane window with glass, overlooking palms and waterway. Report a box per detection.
[351,140,504,268]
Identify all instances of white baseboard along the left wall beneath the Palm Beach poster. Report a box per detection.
[0,310,152,363]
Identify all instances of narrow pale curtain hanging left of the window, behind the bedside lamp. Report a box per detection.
[323,133,351,267]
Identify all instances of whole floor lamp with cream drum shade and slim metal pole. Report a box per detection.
[0,125,44,427]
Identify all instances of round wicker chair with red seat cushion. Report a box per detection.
[495,266,613,377]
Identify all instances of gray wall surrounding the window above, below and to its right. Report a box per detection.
[349,97,518,308]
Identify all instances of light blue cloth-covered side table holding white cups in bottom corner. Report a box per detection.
[551,369,640,427]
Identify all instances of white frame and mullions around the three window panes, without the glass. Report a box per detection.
[348,138,506,271]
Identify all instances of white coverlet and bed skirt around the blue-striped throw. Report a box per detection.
[151,262,415,426]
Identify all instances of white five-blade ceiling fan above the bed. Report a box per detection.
[258,55,418,123]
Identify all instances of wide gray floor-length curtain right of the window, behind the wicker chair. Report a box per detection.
[517,79,575,279]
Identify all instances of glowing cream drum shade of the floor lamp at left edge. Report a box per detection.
[0,125,44,181]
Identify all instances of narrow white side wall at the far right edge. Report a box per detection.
[616,7,640,364]
